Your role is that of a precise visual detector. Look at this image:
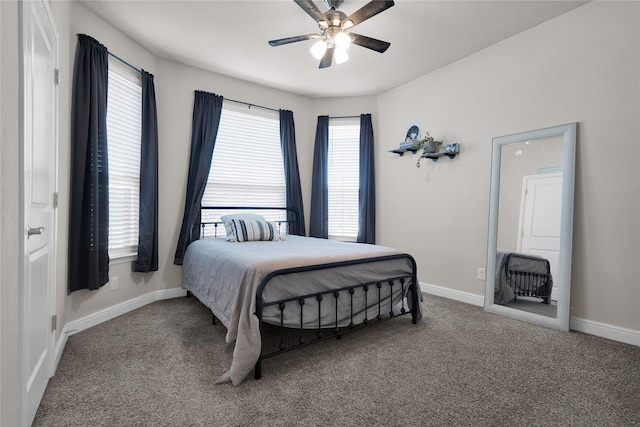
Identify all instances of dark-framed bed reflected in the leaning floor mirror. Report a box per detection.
[494,250,553,305]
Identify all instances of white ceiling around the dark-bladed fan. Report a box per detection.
[81,0,586,97]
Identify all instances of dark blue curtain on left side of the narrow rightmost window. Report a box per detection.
[309,116,329,239]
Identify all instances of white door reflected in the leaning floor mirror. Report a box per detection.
[518,173,562,300]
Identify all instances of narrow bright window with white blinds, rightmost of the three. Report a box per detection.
[327,118,360,240]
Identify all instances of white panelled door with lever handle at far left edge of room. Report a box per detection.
[20,0,57,425]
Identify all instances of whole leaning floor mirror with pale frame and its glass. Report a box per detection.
[485,123,577,331]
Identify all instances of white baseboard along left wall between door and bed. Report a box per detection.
[55,288,187,369]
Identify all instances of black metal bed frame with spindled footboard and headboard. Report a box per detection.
[195,206,420,379]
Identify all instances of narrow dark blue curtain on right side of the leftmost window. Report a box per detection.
[133,70,158,273]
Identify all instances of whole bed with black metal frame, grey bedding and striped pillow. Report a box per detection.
[183,208,421,385]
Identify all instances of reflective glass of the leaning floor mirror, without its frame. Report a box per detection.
[494,137,562,318]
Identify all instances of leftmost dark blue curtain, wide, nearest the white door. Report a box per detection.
[67,34,109,293]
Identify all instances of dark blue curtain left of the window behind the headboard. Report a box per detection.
[174,90,223,265]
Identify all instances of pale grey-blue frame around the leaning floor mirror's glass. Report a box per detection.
[484,123,578,331]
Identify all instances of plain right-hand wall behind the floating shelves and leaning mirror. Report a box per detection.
[377,2,640,339]
